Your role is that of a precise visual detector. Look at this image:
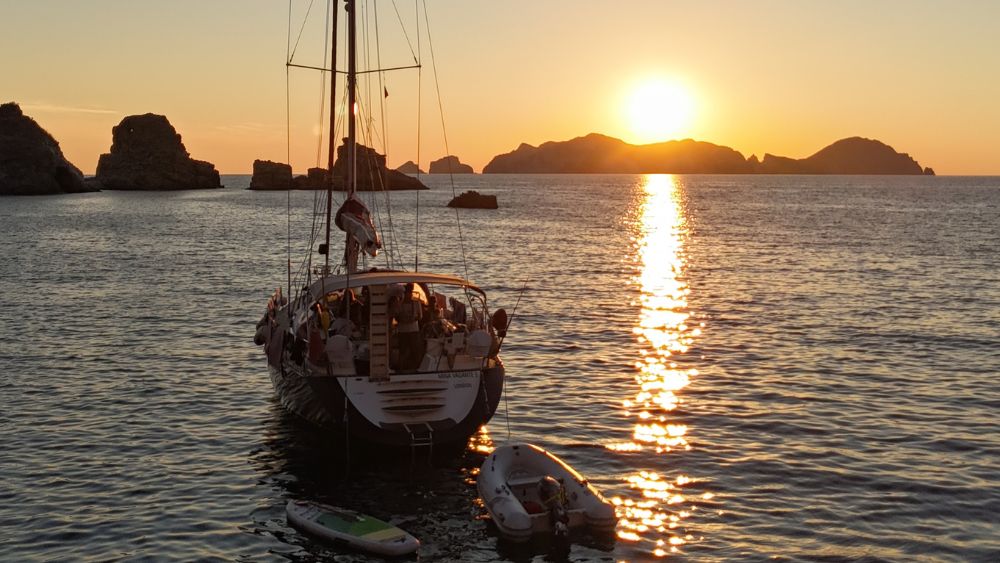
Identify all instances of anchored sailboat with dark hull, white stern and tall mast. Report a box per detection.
[255,0,508,448]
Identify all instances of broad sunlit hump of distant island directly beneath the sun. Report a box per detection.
[483,133,750,174]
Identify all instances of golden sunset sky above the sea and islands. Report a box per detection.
[0,0,1000,174]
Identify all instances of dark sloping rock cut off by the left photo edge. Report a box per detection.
[0,102,97,195]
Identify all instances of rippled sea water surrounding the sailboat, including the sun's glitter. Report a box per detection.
[0,176,1000,561]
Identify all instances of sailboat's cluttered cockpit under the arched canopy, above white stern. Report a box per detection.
[278,271,507,379]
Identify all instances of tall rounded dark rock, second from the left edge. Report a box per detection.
[97,113,222,190]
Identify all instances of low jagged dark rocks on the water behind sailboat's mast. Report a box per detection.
[248,139,430,192]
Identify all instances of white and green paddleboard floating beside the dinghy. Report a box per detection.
[285,500,420,556]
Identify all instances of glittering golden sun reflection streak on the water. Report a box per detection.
[608,175,708,556]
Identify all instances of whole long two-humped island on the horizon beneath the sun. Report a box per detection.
[483,133,934,174]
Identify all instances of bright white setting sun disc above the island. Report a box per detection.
[625,80,694,143]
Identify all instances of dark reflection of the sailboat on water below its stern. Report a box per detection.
[250,402,495,561]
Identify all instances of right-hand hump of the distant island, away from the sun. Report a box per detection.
[753,137,924,174]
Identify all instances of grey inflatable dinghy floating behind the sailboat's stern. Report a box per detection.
[476,444,618,541]
